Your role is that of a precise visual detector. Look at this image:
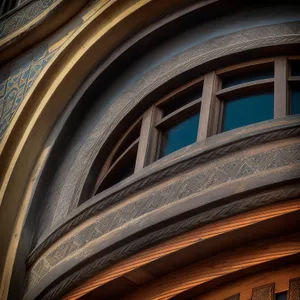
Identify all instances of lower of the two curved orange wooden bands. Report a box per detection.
[124,233,300,300]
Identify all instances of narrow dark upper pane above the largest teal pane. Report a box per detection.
[222,68,274,89]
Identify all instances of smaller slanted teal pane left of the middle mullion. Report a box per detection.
[160,113,199,157]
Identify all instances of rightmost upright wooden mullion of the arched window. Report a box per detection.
[274,57,288,119]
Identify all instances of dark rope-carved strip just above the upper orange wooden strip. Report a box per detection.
[32,185,300,300]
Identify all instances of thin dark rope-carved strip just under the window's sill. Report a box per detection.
[28,123,300,265]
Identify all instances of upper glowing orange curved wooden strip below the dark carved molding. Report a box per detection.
[63,199,300,300]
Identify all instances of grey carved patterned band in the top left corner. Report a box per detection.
[0,0,58,39]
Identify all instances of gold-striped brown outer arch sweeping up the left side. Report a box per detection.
[0,0,195,295]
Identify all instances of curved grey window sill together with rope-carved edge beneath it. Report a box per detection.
[27,116,300,266]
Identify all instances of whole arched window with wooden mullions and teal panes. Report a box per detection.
[94,57,300,194]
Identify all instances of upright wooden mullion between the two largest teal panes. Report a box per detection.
[197,72,220,141]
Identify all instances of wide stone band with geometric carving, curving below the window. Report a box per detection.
[25,138,300,298]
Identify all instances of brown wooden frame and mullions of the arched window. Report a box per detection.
[93,56,300,199]
